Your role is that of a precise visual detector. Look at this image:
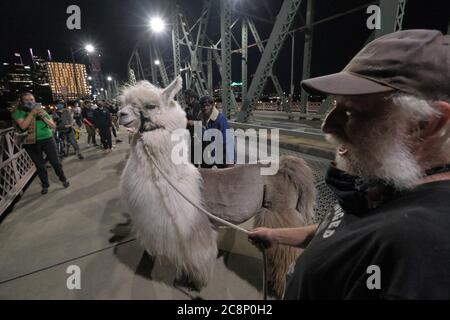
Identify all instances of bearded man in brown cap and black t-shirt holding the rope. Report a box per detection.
[249,30,450,299]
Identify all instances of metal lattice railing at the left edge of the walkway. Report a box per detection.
[0,128,36,216]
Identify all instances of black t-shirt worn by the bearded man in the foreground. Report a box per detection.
[284,181,450,299]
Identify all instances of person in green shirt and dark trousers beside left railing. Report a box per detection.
[12,92,69,194]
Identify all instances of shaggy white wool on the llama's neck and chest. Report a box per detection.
[121,131,217,286]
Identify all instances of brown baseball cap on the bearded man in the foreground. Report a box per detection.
[302,30,450,99]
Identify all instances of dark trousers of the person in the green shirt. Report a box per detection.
[24,137,67,188]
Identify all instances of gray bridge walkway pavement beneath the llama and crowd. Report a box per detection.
[0,128,326,299]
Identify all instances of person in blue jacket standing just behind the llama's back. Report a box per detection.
[199,96,235,168]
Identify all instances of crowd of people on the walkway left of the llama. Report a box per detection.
[10,92,122,194]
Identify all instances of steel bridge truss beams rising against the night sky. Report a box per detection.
[128,0,418,122]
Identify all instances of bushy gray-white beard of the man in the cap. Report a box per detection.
[327,135,422,190]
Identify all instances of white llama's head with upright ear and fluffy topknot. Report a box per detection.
[119,76,187,132]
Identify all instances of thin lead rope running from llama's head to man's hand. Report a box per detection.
[139,134,268,300]
